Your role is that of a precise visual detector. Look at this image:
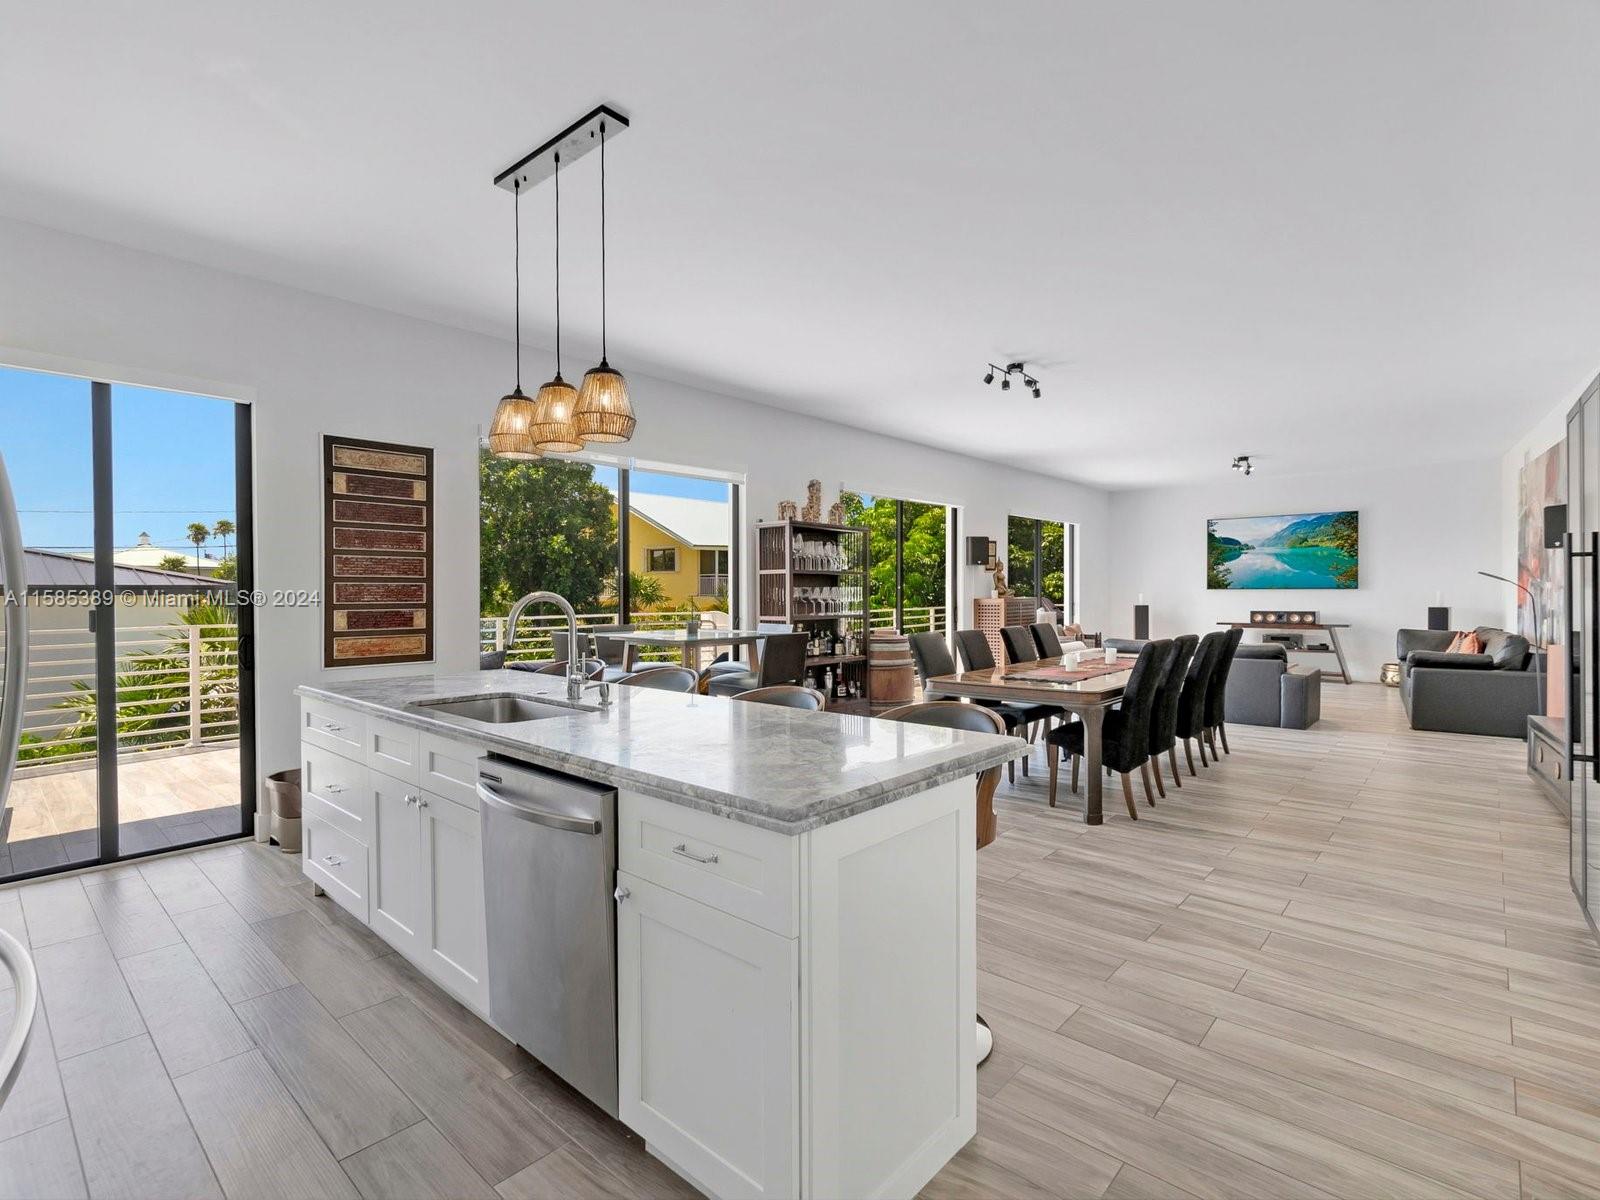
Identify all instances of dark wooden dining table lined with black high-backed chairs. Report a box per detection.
[926,654,1134,826]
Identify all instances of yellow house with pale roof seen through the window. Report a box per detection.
[613,493,728,608]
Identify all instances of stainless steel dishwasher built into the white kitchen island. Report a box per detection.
[478,755,618,1117]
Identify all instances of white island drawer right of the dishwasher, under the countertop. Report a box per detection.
[618,792,800,938]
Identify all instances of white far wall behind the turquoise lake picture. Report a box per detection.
[1106,458,1515,680]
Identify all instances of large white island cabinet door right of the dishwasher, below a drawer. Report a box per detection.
[616,872,800,1197]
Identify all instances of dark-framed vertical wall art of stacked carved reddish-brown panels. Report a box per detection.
[322,435,434,667]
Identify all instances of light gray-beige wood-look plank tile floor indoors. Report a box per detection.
[0,685,1600,1200]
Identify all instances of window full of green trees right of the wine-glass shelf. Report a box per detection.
[840,491,950,634]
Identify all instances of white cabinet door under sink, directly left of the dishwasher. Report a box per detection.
[418,792,490,1013]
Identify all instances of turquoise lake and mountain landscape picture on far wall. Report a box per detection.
[1205,512,1360,590]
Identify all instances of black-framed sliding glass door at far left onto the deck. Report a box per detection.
[0,368,254,878]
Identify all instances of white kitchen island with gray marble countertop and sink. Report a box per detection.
[298,670,1026,1197]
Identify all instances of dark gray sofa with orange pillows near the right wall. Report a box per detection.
[1395,626,1542,738]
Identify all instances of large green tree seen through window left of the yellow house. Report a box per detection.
[478,450,616,616]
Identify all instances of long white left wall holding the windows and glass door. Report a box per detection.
[0,221,1107,790]
